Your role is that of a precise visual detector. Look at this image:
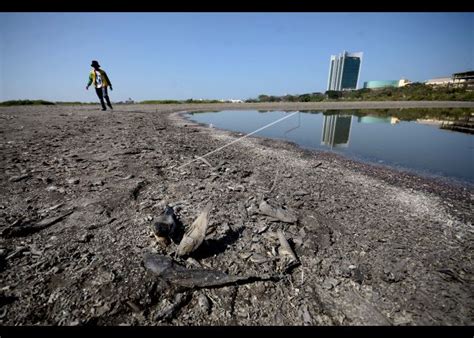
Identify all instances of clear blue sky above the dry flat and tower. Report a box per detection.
[0,13,474,102]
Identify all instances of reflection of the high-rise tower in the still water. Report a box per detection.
[321,115,352,148]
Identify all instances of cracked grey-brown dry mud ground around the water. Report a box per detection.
[0,102,474,325]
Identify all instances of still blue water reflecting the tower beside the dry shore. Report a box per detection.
[188,109,474,184]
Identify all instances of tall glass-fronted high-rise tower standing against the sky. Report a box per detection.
[328,51,363,90]
